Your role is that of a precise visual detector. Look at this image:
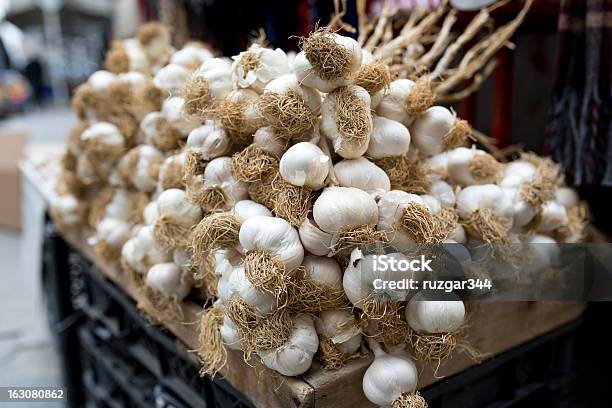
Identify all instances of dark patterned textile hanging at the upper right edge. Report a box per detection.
[546,0,612,186]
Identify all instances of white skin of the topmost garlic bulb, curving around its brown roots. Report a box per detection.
[293,33,363,93]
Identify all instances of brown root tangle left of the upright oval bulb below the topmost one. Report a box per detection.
[259,90,316,139]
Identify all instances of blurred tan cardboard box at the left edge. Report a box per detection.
[0,130,28,230]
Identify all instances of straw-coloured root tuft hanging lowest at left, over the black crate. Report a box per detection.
[196,305,227,376]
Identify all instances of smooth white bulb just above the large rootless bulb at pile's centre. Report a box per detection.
[334,157,391,198]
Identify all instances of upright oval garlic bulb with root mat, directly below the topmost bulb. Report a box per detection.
[321,85,372,159]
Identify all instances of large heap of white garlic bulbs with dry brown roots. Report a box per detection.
[52,25,586,406]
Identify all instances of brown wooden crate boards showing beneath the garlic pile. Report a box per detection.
[63,232,585,408]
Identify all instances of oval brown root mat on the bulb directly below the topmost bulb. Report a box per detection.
[331,87,372,146]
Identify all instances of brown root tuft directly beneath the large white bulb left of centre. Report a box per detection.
[244,250,288,298]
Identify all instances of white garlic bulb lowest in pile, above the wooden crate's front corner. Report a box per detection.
[258,314,319,376]
